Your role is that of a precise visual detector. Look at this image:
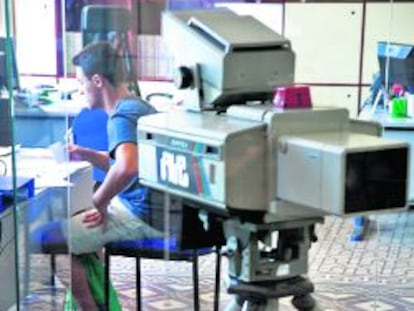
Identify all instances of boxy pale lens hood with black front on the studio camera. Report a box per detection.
[277,132,409,215]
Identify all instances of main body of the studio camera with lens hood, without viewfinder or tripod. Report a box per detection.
[138,105,409,217]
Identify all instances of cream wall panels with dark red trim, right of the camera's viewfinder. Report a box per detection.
[285,1,414,117]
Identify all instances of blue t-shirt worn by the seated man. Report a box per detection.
[107,96,156,220]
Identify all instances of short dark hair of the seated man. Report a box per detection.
[72,41,126,87]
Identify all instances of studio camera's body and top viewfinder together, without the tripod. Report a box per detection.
[137,10,409,221]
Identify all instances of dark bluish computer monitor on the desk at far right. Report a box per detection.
[377,41,414,93]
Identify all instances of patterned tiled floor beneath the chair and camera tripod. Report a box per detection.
[24,210,414,311]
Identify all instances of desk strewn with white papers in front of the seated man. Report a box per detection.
[0,148,94,311]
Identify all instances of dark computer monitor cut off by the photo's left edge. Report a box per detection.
[0,37,19,90]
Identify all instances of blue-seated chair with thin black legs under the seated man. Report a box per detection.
[105,196,224,311]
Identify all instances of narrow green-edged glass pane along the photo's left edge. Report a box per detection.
[0,1,19,310]
